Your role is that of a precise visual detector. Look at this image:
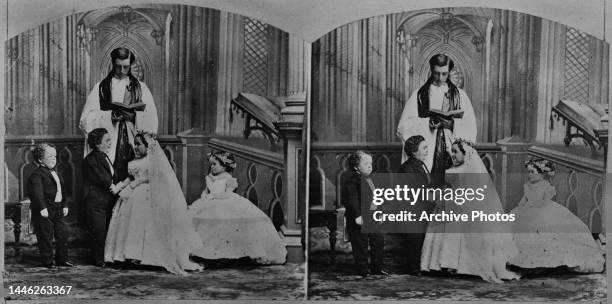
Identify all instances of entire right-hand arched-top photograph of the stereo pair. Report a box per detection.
[308,7,610,302]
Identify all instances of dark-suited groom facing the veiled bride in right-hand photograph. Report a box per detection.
[398,135,433,276]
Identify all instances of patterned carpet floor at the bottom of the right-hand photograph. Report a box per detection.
[308,251,607,302]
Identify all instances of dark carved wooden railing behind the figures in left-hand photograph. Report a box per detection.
[4,136,297,254]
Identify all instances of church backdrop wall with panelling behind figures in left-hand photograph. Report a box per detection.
[4,5,310,254]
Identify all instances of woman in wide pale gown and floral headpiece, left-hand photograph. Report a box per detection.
[189,152,287,264]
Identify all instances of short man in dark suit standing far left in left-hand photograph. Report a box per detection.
[28,143,74,268]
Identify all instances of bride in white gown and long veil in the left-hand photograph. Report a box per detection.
[104,134,202,274]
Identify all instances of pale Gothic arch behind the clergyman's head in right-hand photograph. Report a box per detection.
[397,8,493,141]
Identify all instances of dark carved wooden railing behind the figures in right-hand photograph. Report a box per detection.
[309,142,605,233]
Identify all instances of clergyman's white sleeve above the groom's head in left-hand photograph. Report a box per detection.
[79,83,113,134]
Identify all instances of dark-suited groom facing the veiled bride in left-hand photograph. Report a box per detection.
[83,128,117,267]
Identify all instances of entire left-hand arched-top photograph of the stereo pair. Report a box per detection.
[3,1,310,300]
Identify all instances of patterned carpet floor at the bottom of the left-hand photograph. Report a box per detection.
[4,246,305,300]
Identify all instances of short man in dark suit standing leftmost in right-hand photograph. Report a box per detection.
[341,151,387,277]
